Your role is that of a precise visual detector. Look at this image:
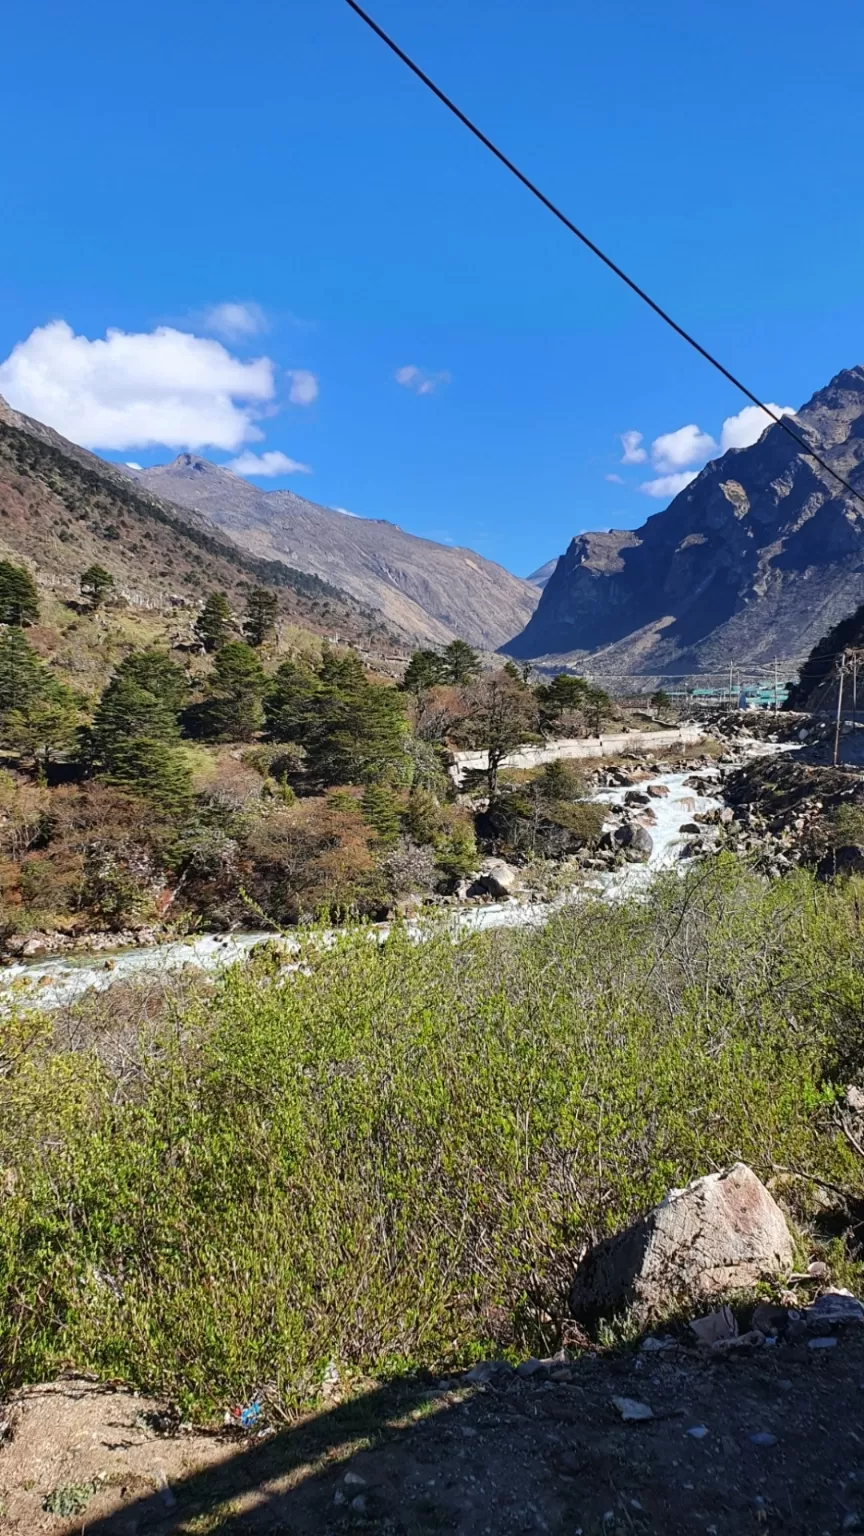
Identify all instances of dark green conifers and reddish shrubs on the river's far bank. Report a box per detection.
[0,561,621,957]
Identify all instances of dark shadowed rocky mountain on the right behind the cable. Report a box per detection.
[501,367,864,676]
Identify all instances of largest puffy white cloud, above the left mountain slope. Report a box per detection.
[0,319,275,452]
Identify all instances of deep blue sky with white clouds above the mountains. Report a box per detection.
[0,0,864,574]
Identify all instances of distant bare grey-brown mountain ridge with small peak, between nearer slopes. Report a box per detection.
[126,453,537,650]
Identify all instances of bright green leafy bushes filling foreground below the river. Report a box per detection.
[0,860,864,1410]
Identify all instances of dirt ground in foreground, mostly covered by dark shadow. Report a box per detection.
[0,1330,864,1536]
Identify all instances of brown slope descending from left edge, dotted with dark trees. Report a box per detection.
[0,398,389,648]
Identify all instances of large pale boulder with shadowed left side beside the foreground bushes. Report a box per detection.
[570,1163,793,1321]
